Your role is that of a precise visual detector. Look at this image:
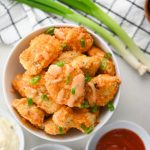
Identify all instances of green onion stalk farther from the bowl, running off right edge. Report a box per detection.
[59,0,150,71]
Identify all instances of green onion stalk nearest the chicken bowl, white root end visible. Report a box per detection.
[16,0,147,75]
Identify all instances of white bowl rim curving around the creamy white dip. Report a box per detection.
[0,110,24,150]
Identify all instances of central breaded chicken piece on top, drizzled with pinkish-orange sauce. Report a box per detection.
[45,62,85,107]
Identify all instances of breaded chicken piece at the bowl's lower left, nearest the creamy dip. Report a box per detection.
[12,98,45,127]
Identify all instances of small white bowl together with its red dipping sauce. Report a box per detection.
[86,121,150,150]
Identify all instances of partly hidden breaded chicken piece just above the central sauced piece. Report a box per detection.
[54,51,81,64]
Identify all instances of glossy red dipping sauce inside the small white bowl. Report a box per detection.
[96,129,146,150]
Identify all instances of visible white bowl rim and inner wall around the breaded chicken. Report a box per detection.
[3,24,120,142]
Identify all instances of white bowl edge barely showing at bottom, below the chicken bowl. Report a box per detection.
[31,144,72,150]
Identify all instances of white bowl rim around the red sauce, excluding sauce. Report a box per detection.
[86,120,150,150]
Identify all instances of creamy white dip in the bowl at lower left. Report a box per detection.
[0,117,19,150]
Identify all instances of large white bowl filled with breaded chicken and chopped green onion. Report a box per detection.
[3,24,121,142]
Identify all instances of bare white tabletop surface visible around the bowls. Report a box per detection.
[0,46,150,150]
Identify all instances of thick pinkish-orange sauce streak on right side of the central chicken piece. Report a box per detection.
[68,74,85,107]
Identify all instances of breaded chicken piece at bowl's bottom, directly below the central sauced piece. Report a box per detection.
[52,106,96,132]
